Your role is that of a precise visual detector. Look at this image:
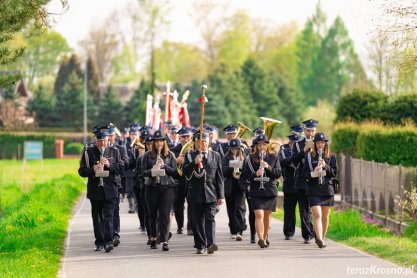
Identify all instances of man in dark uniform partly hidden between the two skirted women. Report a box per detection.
[279,134,298,240]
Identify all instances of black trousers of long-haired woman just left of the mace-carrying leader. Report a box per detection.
[145,186,174,242]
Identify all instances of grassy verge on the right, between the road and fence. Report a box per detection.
[274,210,417,267]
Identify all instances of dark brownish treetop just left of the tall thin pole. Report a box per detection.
[54,54,84,96]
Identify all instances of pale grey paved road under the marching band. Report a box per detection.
[59,195,417,278]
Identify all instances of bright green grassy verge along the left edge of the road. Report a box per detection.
[0,174,85,277]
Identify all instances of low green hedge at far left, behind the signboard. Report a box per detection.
[0,132,82,159]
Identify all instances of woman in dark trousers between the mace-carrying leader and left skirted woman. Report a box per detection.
[222,138,245,241]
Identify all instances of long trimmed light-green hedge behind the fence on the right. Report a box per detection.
[332,123,417,166]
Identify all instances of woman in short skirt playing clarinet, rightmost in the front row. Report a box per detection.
[303,132,337,248]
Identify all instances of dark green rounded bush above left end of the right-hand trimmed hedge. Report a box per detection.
[336,90,388,122]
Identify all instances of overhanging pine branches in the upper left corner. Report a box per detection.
[0,0,67,87]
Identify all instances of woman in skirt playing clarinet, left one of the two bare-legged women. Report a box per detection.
[240,134,281,248]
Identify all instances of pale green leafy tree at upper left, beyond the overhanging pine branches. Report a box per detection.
[19,31,70,88]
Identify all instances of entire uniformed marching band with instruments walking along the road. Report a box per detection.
[78,87,337,254]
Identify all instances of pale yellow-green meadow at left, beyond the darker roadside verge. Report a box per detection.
[0,159,79,212]
